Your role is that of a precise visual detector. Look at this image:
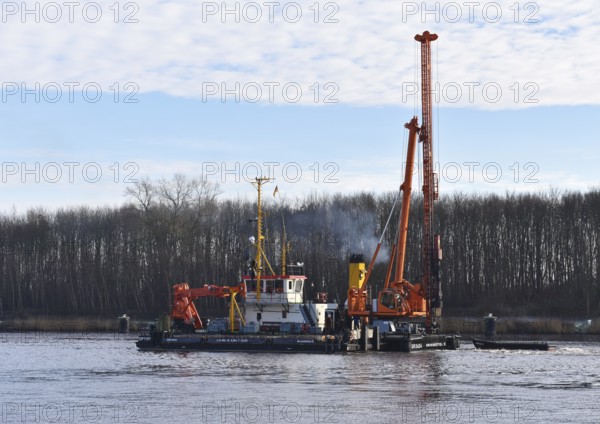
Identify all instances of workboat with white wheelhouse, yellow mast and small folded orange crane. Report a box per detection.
[136,178,343,353]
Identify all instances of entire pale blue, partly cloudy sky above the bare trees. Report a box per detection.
[0,0,600,213]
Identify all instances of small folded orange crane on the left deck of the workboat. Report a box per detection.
[171,283,246,331]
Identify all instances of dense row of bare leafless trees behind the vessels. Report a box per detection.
[0,175,600,319]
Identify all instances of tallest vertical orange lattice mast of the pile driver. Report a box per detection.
[415,31,441,333]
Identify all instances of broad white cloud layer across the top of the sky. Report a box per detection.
[0,0,600,109]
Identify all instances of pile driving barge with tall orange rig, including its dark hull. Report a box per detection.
[348,31,459,351]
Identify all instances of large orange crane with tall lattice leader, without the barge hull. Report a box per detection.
[348,31,442,334]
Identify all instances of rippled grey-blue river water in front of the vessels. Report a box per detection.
[0,333,600,424]
